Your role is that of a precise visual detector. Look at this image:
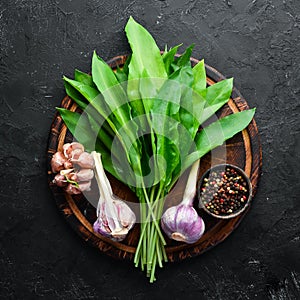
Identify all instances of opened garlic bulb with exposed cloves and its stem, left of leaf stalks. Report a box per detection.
[92,151,136,241]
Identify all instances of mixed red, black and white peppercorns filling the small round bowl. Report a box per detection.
[200,166,249,216]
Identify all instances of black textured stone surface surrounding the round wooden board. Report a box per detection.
[0,0,300,299]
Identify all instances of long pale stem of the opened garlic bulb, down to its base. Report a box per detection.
[92,151,122,231]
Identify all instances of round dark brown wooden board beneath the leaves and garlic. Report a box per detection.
[47,55,262,261]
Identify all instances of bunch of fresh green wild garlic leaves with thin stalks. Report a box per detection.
[58,17,254,282]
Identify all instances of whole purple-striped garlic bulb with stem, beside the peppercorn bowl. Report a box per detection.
[161,160,205,244]
